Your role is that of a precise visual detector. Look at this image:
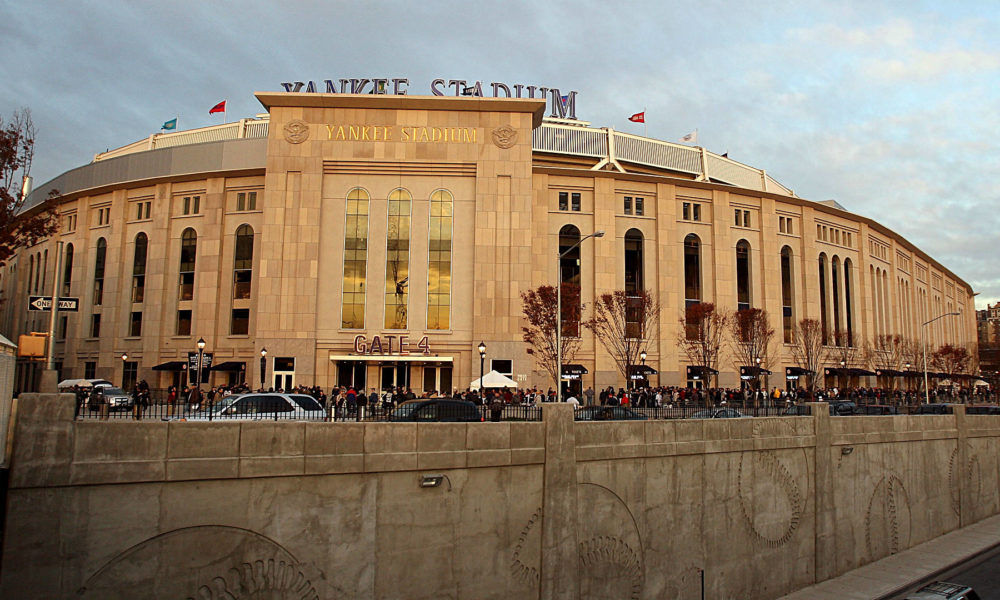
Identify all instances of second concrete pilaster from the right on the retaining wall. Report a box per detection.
[808,402,837,582]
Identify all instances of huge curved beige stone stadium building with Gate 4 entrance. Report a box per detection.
[0,92,976,391]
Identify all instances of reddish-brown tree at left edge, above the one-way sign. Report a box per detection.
[0,109,59,266]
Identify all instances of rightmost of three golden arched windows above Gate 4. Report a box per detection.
[427,190,455,329]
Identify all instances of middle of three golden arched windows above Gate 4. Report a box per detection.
[385,189,413,329]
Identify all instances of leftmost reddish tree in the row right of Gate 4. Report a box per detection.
[521,283,580,390]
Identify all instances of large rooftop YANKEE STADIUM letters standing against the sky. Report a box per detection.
[281,77,576,119]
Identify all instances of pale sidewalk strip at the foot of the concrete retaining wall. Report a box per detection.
[779,515,1000,600]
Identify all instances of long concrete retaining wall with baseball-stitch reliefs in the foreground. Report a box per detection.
[0,395,1000,600]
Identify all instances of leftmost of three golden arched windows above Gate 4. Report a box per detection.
[340,188,370,329]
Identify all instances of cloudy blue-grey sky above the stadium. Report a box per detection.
[0,0,1000,308]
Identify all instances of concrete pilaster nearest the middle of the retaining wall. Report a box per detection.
[538,403,580,600]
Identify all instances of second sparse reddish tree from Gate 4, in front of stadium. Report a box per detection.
[583,290,660,385]
